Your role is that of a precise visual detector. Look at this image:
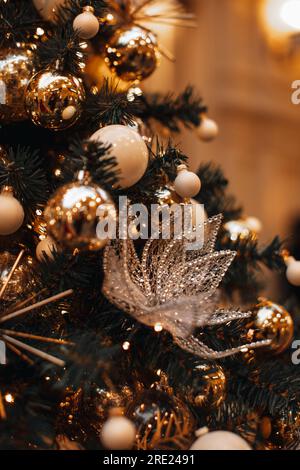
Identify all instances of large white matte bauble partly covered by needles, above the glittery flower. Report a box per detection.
[90,125,149,188]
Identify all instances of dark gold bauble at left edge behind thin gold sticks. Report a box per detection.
[0,251,35,302]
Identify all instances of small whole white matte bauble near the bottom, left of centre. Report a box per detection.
[101,416,136,450]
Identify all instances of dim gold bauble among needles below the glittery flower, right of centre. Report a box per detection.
[187,364,226,408]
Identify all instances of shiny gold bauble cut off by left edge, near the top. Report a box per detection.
[0,44,34,123]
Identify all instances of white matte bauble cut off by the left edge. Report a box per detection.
[0,187,25,235]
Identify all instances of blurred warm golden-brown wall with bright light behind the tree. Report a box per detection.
[147,0,300,243]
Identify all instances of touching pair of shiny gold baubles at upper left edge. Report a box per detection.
[0,44,85,130]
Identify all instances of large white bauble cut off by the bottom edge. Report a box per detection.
[191,431,252,450]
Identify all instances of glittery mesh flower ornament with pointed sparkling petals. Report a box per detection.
[103,215,269,359]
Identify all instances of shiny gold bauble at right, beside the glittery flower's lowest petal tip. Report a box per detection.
[254,300,294,354]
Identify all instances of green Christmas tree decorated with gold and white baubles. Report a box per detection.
[0,0,300,450]
